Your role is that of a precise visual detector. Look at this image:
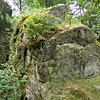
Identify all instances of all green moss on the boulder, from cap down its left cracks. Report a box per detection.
[10,8,87,100]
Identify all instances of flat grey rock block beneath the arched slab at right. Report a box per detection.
[44,43,100,77]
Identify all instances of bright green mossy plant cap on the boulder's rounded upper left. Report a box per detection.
[10,12,58,49]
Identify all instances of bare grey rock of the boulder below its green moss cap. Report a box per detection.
[10,5,100,100]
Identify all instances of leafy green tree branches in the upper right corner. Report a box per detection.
[77,0,100,34]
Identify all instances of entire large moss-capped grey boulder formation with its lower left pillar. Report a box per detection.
[11,5,100,100]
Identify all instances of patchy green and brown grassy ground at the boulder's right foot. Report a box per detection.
[45,76,100,100]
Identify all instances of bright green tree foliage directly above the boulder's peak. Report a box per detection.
[22,0,74,9]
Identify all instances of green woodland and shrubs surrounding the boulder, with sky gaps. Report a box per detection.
[0,0,100,100]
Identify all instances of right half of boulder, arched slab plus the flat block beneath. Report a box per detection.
[39,25,100,77]
